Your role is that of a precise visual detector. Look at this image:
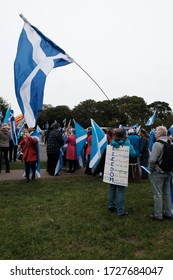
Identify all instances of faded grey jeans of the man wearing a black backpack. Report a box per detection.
[151,171,171,219]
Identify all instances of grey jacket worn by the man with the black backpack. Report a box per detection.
[149,136,170,173]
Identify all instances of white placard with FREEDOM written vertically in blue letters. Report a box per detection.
[103,145,129,187]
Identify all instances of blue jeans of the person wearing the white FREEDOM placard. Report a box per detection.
[108,184,126,216]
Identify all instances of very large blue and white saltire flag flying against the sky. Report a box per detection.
[14,15,73,127]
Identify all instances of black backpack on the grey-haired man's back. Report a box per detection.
[156,140,173,171]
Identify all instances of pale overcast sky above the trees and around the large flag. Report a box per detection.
[0,0,173,115]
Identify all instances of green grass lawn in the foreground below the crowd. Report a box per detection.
[0,175,173,260]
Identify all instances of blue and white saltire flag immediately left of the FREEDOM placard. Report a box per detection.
[89,119,108,168]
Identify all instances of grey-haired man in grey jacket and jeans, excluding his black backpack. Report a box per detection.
[149,126,172,221]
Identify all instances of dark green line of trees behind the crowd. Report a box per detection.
[0,95,173,129]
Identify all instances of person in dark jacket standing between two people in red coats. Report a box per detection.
[46,123,64,176]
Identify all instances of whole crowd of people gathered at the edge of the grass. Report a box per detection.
[0,122,173,221]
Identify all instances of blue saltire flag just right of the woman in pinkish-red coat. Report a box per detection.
[73,120,87,167]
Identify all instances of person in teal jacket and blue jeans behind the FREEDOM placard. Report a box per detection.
[108,128,136,216]
